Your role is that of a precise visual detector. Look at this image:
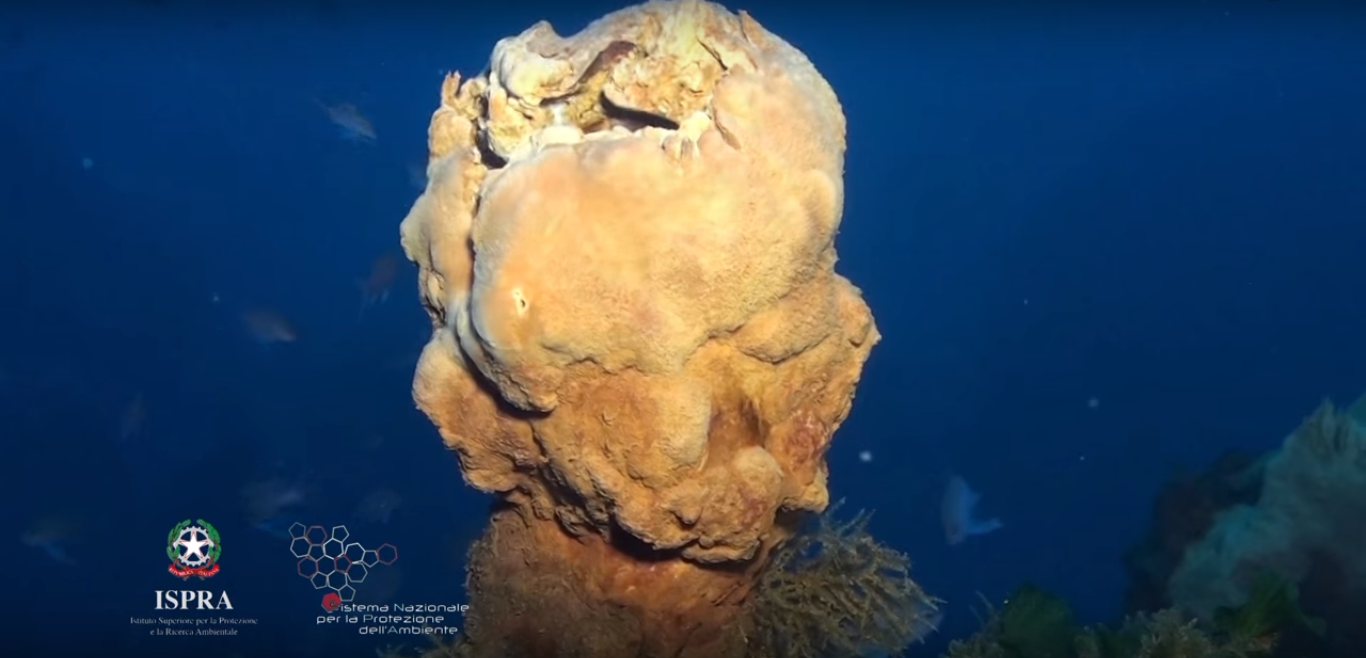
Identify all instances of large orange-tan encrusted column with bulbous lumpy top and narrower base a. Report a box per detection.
[402,0,878,658]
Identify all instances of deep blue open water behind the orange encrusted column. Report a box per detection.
[0,0,1366,655]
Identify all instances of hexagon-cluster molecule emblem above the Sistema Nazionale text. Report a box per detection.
[290,523,399,613]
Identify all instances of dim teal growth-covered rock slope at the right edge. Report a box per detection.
[1126,397,1366,658]
